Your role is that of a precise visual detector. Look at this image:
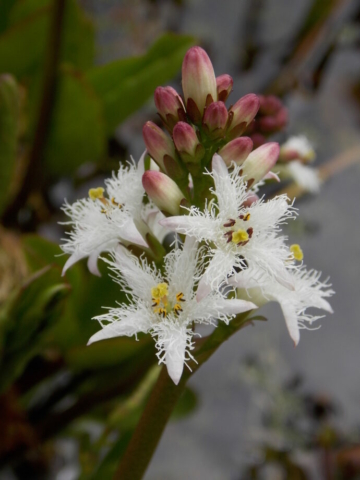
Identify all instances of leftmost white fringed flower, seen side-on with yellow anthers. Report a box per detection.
[61,154,147,275]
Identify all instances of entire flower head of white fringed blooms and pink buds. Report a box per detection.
[62,47,333,383]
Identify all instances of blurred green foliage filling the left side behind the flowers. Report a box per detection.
[0,0,196,479]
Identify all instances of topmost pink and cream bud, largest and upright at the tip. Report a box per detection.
[182,47,217,122]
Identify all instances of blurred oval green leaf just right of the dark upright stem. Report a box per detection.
[45,64,106,175]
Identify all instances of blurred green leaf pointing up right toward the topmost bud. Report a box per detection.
[87,33,193,133]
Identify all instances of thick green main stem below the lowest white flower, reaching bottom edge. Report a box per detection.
[114,366,186,480]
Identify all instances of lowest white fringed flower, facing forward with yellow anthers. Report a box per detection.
[89,237,256,384]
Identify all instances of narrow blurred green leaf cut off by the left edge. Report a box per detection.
[0,75,20,213]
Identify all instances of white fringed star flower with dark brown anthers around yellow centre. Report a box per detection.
[160,155,295,300]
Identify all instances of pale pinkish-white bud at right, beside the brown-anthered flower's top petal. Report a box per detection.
[241,142,280,187]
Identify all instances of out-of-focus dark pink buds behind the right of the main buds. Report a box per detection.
[246,95,288,147]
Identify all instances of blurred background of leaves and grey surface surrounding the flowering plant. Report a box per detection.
[0,0,360,480]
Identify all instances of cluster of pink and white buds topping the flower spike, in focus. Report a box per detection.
[143,47,285,212]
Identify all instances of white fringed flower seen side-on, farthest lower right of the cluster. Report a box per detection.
[229,267,334,345]
